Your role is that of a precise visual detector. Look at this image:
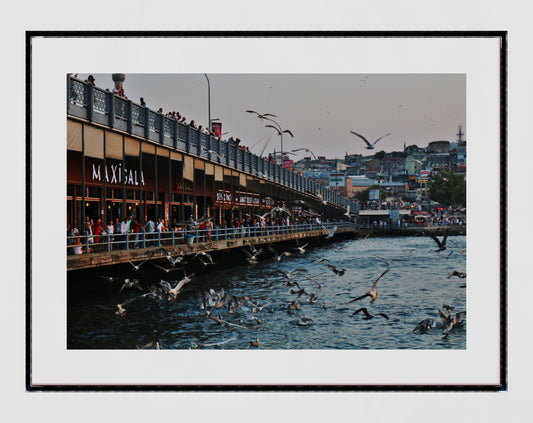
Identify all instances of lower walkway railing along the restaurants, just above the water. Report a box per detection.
[67,222,355,255]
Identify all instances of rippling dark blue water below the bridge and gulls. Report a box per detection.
[67,236,467,350]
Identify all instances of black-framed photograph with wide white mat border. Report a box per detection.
[26,31,507,391]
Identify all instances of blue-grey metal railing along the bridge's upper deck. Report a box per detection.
[67,76,358,212]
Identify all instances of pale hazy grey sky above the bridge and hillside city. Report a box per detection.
[78,70,467,160]
